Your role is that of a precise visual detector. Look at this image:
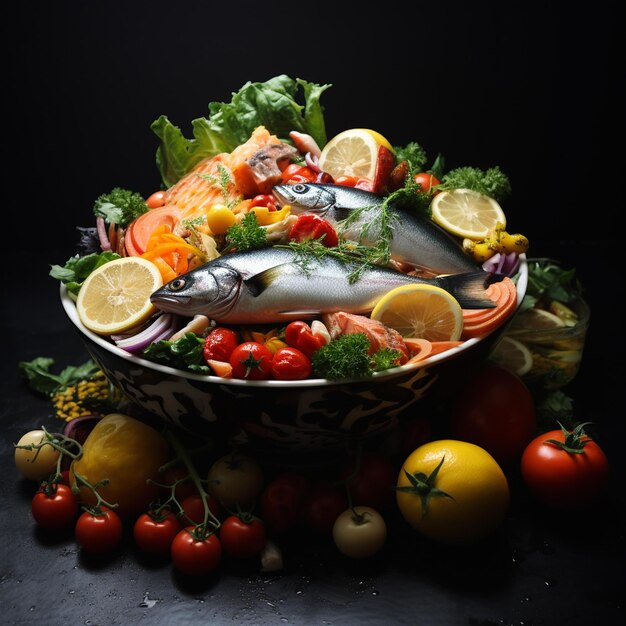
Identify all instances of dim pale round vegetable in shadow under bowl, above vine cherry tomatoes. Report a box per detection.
[207,452,263,510]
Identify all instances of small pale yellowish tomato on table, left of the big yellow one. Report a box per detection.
[333,506,387,559]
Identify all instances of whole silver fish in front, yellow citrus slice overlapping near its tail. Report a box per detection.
[150,247,494,324]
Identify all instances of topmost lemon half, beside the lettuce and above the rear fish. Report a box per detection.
[319,128,393,179]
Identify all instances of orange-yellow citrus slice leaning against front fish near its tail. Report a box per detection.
[370,284,463,341]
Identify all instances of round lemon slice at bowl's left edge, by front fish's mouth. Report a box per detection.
[76,256,163,335]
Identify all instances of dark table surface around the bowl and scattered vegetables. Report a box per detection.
[0,242,626,626]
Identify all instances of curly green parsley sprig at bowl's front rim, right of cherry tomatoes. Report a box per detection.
[312,333,401,380]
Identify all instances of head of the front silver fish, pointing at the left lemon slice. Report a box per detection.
[150,263,242,319]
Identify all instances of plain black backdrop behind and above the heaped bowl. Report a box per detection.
[3,0,623,264]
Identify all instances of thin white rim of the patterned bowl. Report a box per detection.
[60,254,528,389]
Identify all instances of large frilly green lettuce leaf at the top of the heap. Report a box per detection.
[150,74,331,187]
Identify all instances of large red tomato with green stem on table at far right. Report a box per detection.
[521,424,609,511]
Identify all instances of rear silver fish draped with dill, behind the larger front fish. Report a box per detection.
[272,183,478,274]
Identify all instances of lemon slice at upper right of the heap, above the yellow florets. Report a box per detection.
[430,189,506,241]
